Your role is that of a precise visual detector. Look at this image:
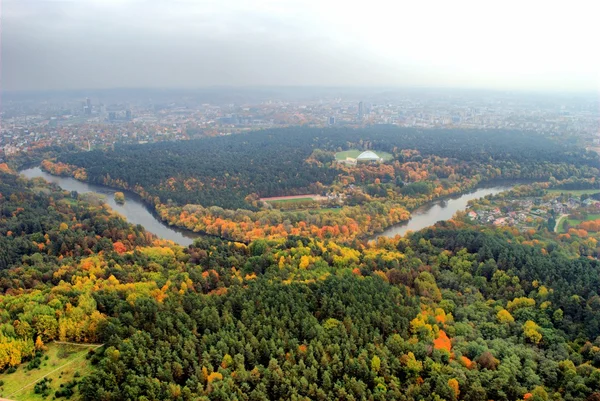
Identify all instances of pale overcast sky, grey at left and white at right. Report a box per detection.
[0,0,600,92]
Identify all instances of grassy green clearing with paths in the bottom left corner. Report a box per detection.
[0,343,97,401]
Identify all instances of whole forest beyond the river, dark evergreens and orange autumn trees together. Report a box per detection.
[34,126,600,243]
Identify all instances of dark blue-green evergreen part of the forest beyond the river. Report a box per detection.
[58,126,599,210]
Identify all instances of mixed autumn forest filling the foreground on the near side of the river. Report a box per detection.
[0,165,600,401]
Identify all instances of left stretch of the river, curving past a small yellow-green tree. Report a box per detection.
[19,167,200,246]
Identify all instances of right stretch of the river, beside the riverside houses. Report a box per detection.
[375,183,514,238]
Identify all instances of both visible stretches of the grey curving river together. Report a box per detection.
[19,167,514,246]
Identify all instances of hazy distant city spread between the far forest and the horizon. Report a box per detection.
[0,89,600,157]
